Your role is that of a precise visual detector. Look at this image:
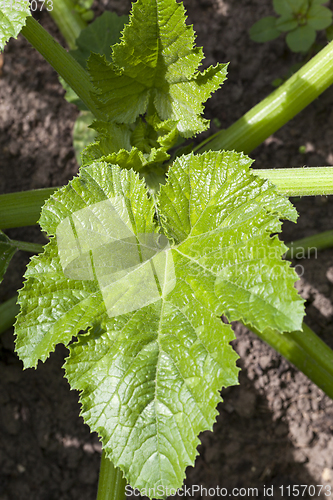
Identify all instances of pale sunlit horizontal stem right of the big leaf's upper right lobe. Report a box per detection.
[252,166,333,196]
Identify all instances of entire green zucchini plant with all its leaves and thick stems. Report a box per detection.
[0,0,333,500]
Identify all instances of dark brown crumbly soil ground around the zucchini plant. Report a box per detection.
[0,0,333,500]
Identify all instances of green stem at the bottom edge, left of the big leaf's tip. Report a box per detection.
[97,450,126,500]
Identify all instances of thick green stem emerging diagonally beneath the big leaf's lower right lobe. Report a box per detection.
[249,323,333,399]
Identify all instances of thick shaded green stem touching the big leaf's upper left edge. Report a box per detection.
[0,188,57,229]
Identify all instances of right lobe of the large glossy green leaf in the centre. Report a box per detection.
[160,152,304,331]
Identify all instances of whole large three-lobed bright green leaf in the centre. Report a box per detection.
[16,152,303,492]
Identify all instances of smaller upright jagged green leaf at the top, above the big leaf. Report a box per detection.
[88,0,227,137]
